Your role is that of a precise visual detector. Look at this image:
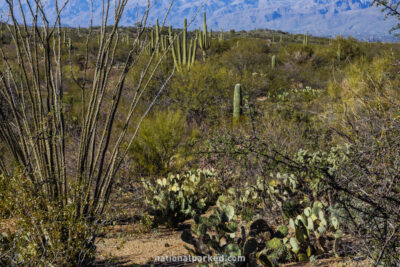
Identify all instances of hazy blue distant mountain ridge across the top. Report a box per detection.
[0,0,397,40]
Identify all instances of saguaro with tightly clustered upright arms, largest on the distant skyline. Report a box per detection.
[168,19,197,72]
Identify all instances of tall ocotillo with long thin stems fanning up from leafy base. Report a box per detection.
[0,0,174,266]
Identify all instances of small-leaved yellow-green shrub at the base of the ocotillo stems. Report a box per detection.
[0,174,98,266]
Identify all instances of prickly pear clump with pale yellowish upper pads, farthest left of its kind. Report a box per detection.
[142,170,219,227]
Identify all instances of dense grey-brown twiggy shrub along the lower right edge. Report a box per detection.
[326,105,400,266]
